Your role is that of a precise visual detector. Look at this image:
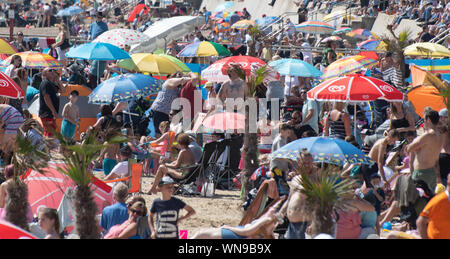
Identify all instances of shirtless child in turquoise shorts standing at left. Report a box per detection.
[61,90,80,139]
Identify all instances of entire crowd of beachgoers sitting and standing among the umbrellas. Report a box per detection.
[0,0,450,239]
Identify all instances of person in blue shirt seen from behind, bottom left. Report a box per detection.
[100,183,128,236]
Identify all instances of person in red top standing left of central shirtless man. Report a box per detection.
[180,72,203,121]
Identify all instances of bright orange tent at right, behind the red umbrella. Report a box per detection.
[407,85,446,118]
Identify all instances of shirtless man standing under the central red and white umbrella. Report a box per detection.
[218,66,248,110]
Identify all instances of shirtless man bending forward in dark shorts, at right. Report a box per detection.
[361,129,400,189]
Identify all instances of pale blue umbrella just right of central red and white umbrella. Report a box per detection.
[269,58,322,77]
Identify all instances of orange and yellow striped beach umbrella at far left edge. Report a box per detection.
[2,51,62,69]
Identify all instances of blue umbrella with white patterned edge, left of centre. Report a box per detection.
[89,73,161,104]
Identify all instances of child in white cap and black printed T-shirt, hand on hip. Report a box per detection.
[148,176,195,239]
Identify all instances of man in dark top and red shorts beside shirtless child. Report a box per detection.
[39,68,64,137]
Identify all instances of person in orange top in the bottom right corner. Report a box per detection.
[416,174,450,239]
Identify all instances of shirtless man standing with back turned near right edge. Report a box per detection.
[406,110,443,192]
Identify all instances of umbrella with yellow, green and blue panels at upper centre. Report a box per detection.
[178,41,231,57]
